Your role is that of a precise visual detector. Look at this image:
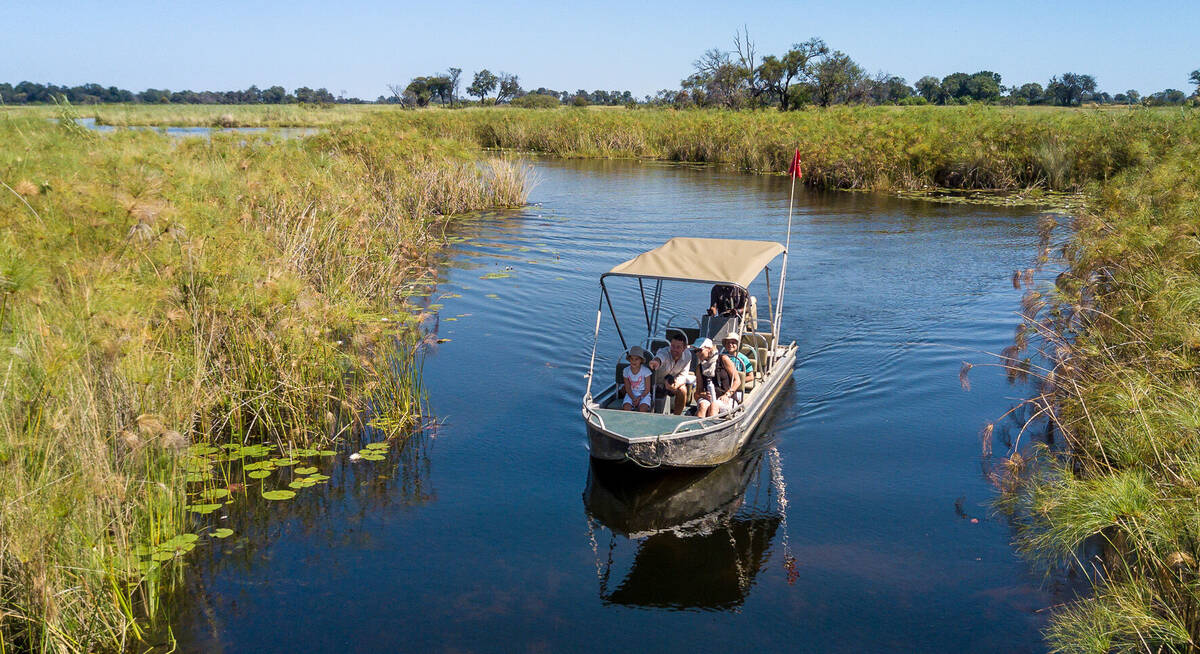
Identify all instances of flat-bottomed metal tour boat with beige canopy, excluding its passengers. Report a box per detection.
[582,238,797,468]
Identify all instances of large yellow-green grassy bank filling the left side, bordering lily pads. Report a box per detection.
[0,108,527,652]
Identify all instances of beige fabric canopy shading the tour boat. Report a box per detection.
[601,236,784,288]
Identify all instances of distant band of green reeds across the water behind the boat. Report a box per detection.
[386,106,1196,191]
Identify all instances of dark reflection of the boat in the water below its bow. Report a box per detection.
[583,443,790,611]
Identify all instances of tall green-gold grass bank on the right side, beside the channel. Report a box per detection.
[993,127,1200,652]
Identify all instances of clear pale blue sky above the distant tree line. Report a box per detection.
[0,0,1200,98]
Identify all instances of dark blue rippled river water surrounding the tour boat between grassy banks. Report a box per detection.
[175,161,1066,653]
